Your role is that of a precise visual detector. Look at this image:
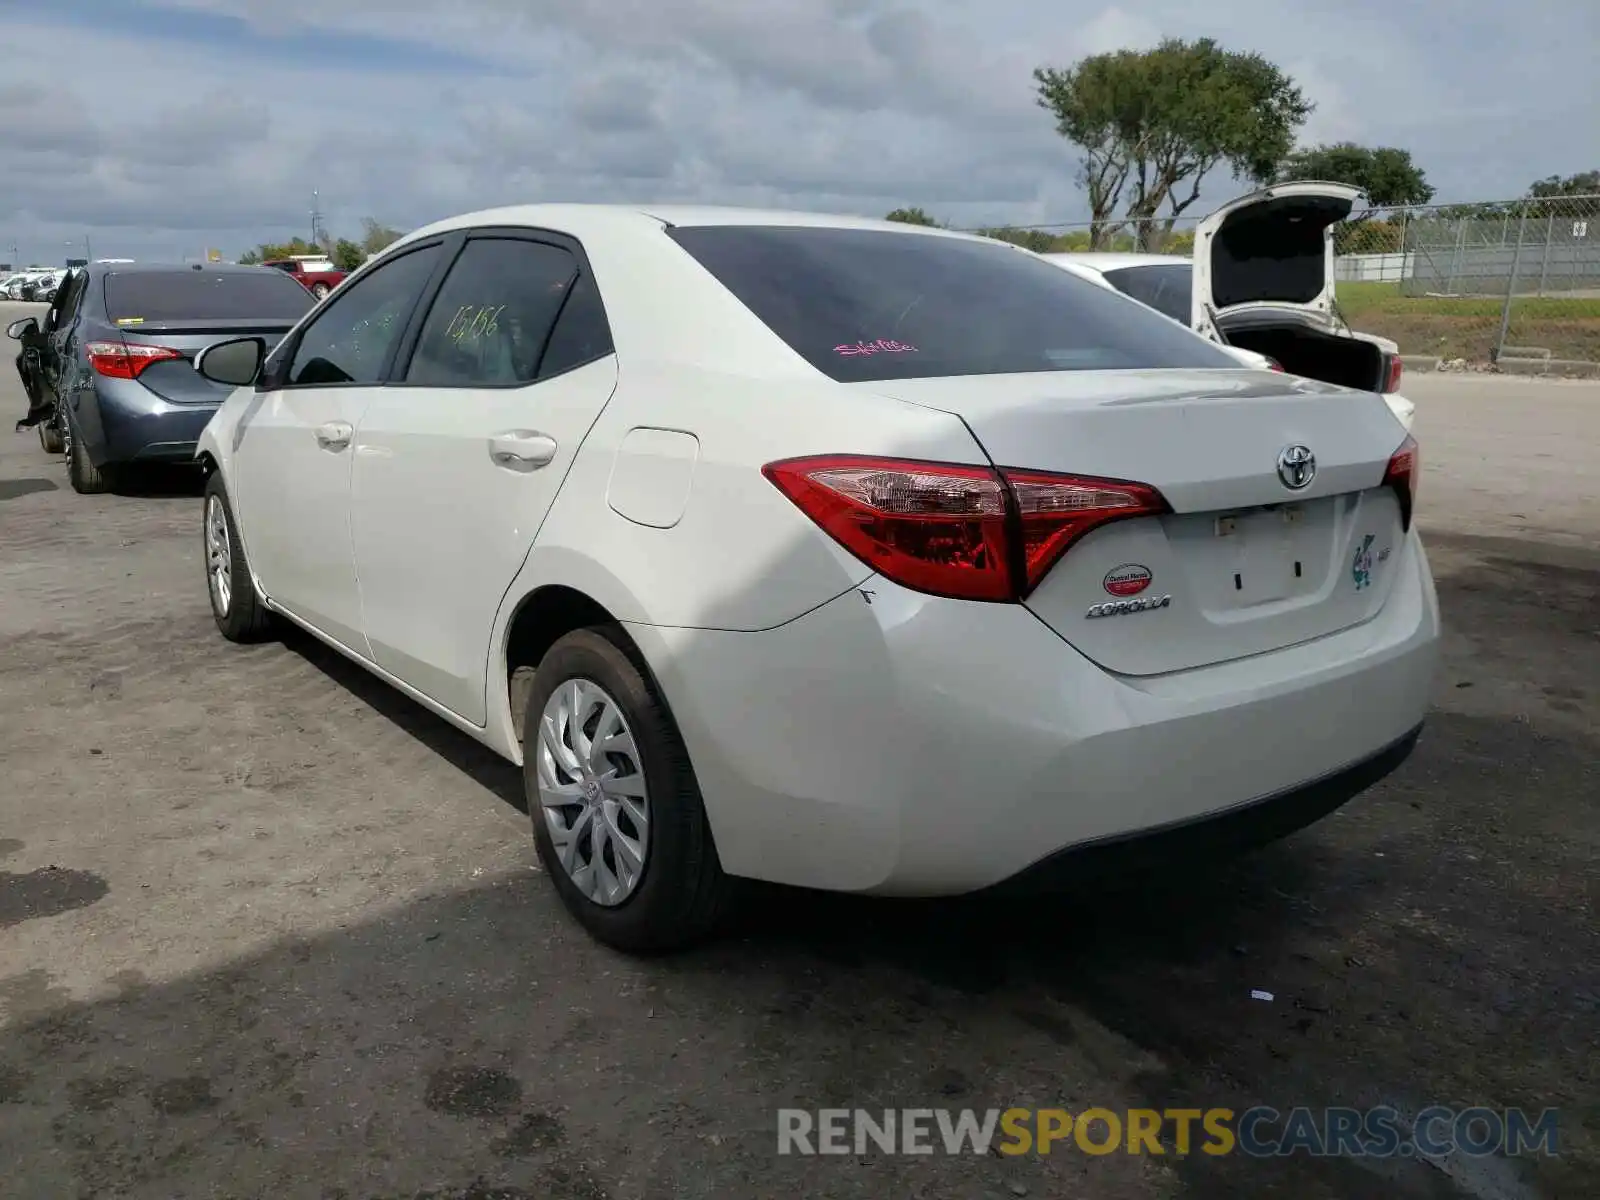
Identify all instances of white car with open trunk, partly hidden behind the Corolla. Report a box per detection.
[1045,182,1416,429]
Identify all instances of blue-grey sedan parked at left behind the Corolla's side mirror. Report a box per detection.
[8,264,315,493]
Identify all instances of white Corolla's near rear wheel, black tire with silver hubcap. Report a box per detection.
[518,627,731,954]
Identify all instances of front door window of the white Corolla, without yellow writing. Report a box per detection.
[286,245,440,386]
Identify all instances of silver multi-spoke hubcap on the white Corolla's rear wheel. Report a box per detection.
[536,678,650,907]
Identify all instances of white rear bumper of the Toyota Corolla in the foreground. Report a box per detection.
[634,533,1438,896]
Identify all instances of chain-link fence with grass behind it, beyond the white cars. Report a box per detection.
[978,195,1600,376]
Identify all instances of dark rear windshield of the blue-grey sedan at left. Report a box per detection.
[106,269,317,322]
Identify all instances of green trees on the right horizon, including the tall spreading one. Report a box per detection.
[888,38,1600,253]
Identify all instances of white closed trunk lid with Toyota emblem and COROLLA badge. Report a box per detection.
[874,370,1405,675]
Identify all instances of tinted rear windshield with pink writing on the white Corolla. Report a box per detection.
[669,226,1235,382]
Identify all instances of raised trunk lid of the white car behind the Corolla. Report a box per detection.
[1190,181,1363,341]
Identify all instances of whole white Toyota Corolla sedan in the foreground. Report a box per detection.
[195,206,1438,950]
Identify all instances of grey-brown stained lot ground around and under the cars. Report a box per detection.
[0,312,1600,1200]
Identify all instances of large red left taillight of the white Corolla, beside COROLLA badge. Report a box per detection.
[762,454,1168,602]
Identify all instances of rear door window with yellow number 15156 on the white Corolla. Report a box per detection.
[405,238,578,387]
